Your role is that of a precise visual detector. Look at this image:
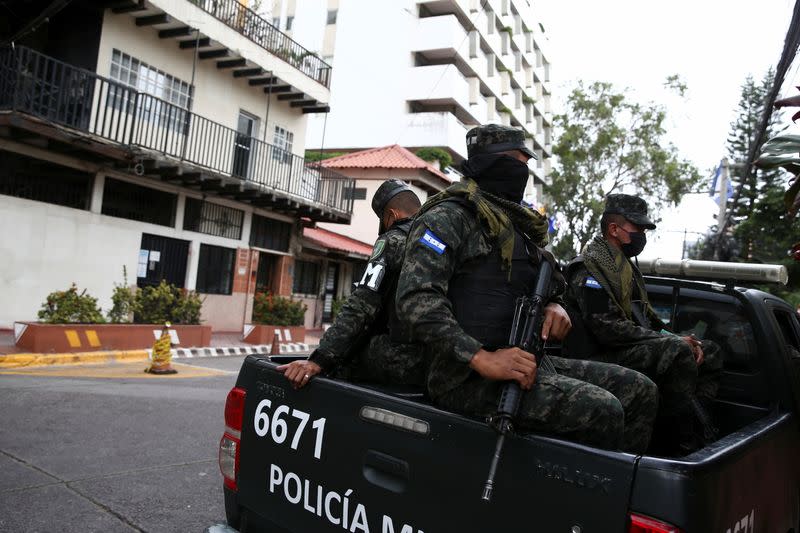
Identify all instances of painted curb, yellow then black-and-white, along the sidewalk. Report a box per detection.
[0,343,315,370]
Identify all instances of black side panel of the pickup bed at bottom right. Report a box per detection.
[631,414,800,533]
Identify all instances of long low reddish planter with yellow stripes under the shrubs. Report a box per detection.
[14,322,211,353]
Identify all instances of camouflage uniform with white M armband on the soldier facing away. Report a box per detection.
[309,182,426,385]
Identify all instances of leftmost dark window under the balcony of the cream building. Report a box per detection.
[0,151,94,209]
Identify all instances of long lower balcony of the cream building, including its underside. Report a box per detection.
[0,47,355,222]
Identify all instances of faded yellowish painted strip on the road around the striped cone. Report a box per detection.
[0,361,230,380]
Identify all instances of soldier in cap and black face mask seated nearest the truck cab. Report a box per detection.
[566,194,722,454]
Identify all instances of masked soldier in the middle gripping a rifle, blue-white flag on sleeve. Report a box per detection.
[397,125,657,452]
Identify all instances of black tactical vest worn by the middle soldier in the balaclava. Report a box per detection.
[447,232,539,349]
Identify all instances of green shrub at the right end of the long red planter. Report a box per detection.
[133,279,203,324]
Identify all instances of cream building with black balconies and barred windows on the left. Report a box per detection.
[0,0,354,331]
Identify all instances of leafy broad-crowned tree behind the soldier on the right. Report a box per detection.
[545,78,700,259]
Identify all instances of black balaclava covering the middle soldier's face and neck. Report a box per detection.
[461,154,528,203]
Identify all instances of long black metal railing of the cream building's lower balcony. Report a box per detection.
[0,47,355,214]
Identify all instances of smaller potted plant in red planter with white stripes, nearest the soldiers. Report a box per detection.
[244,292,308,344]
